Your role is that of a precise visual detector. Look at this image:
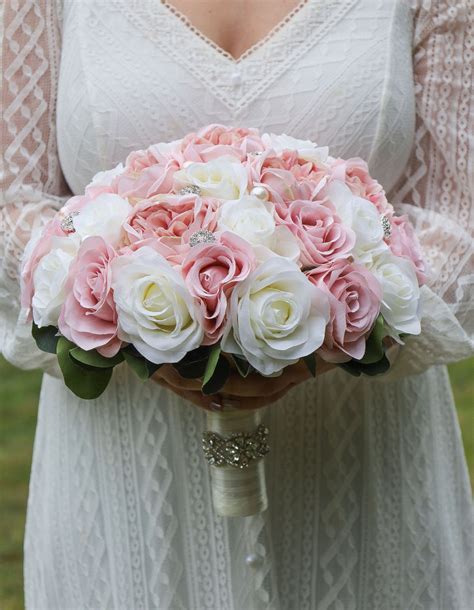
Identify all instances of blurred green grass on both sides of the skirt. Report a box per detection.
[0,358,474,610]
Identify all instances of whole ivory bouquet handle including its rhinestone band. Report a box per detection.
[203,409,269,517]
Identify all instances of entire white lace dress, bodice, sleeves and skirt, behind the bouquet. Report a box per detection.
[0,0,474,610]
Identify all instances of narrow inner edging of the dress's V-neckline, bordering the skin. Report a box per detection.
[160,0,312,66]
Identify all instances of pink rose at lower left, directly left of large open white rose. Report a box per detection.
[59,237,122,358]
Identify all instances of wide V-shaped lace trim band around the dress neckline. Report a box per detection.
[111,0,357,114]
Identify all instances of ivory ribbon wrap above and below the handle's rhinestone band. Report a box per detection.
[207,409,268,517]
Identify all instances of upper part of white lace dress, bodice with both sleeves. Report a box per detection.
[0,0,473,374]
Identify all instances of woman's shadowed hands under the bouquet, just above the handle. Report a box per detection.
[152,357,335,411]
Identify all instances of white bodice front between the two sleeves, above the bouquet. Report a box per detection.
[58,0,414,192]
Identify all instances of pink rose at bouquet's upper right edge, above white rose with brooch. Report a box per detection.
[331,157,393,214]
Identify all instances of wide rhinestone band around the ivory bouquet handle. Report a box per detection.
[202,424,270,469]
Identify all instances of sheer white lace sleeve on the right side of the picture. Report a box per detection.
[389,0,474,377]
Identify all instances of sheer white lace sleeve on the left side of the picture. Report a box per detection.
[0,0,71,369]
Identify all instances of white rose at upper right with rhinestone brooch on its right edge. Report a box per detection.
[327,181,389,265]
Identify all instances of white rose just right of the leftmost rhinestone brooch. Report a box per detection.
[73,193,132,246]
